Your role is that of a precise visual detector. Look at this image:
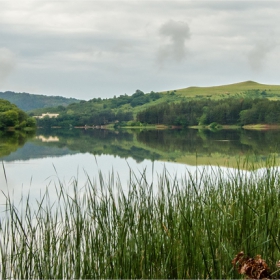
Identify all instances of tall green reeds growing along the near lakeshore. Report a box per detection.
[0,163,280,279]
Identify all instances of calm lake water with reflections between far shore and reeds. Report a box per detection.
[0,129,280,207]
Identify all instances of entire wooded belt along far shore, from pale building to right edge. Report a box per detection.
[37,95,280,127]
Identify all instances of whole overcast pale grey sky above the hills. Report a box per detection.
[0,0,280,100]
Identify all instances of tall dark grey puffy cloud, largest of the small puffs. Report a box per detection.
[157,20,190,64]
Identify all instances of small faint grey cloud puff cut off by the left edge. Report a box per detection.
[0,48,16,83]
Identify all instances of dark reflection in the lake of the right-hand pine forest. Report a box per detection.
[137,129,280,155]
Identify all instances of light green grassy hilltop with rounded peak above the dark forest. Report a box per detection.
[163,81,280,100]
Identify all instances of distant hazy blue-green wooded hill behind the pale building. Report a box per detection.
[0,91,80,111]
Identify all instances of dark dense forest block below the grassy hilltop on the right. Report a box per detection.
[136,98,280,126]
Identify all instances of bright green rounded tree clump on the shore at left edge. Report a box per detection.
[0,99,36,130]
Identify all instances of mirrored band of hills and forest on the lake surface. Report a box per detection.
[3,129,280,166]
